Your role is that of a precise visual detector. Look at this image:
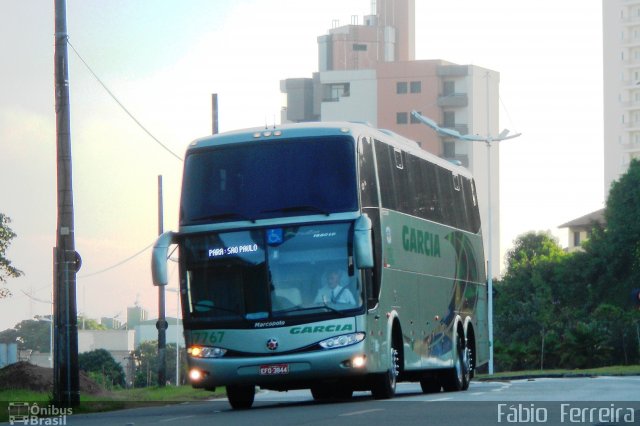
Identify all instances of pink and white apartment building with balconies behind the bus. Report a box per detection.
[280,0,501,276]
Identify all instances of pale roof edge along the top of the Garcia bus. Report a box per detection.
[188,121,471,177]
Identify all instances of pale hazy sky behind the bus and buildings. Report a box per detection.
[0,0,605,330]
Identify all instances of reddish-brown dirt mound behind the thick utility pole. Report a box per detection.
[0,362,102,395]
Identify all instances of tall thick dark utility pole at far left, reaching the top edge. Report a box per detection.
[53,0,81,407]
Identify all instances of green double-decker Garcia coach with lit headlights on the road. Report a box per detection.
[152,123,489,409]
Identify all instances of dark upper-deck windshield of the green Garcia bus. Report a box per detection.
[180,136,358,225]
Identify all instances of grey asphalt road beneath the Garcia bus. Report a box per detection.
[20,377,640,426]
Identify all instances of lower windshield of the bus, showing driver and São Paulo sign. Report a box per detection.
[183,222,364,321]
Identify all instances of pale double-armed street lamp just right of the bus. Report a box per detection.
[411,108,521,374]
